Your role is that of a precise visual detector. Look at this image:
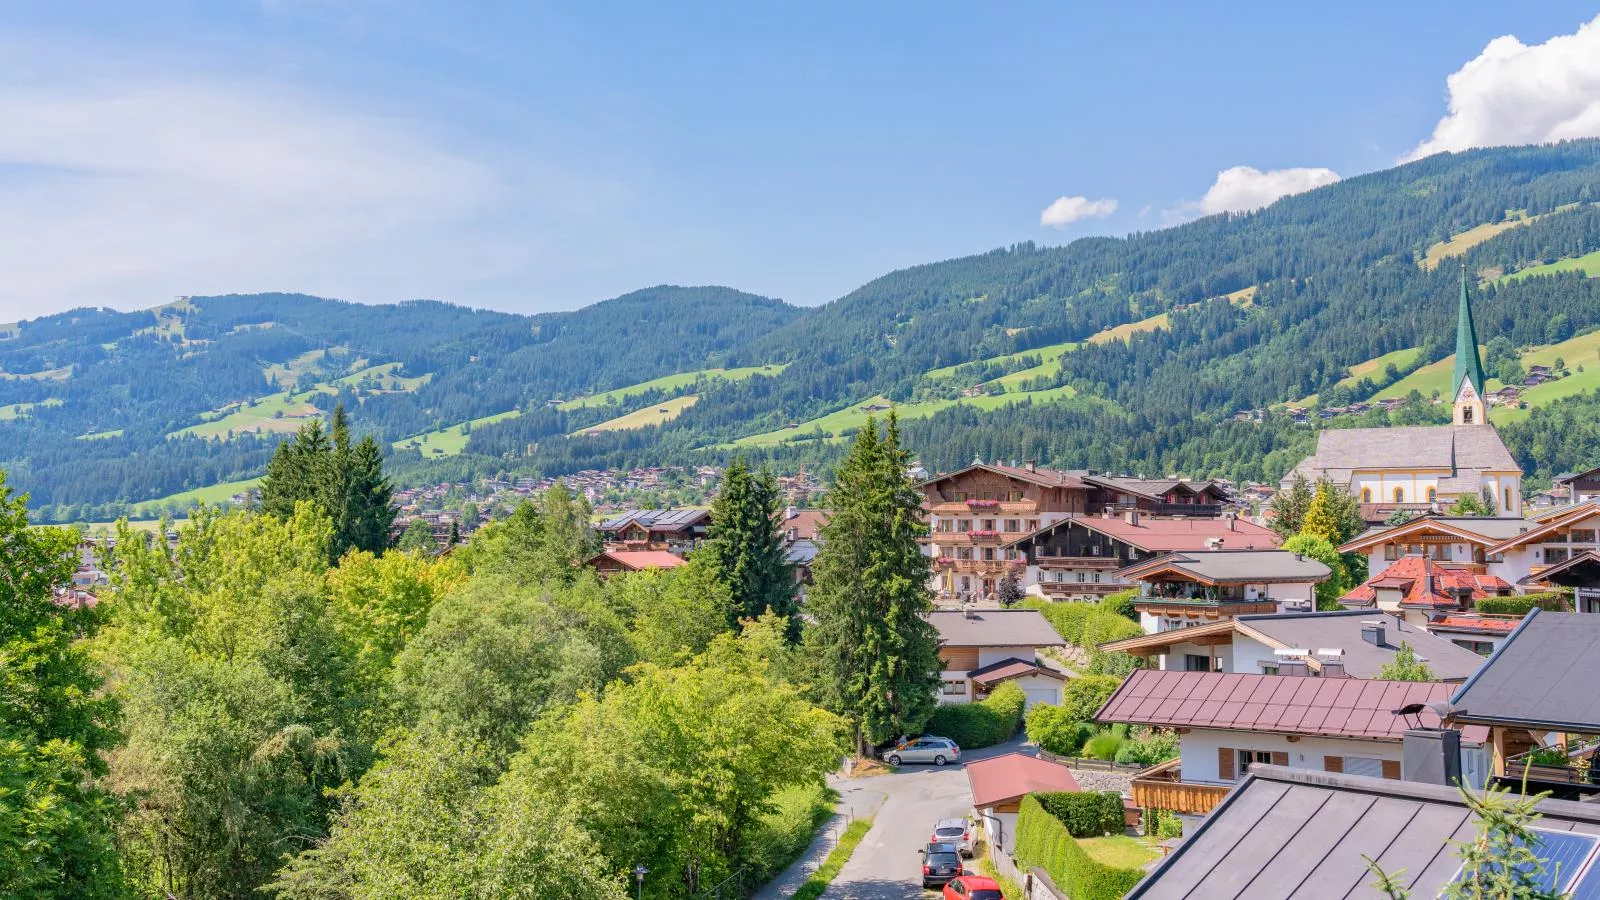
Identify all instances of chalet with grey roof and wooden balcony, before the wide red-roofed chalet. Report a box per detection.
[1117,549,1333,634]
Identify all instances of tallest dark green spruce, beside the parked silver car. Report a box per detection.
[806,413,939,754]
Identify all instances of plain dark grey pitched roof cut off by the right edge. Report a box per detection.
[1450,609,1600,733]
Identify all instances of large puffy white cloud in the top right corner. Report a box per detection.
[1402,16,1600,162]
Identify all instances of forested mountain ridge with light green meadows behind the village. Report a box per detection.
[0,141,1600,518]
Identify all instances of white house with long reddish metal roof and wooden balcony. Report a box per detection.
[1094,669,1490,831]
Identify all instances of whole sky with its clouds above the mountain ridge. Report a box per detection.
[0,0,1600,319]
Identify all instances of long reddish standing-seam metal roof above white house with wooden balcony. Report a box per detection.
[1094,669,1478,740]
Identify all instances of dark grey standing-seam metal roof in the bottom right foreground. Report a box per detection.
[1128,762,1600,900]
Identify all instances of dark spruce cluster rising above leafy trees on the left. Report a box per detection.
[261,404,395,559]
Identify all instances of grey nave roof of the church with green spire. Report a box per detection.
[1286,424,1522,482]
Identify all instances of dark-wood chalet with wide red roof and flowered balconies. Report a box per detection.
[1002,509,1282,601]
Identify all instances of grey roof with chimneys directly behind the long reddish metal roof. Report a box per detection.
[1238,610,1483,681]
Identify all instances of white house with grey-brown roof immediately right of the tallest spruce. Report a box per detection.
[928,609,1067,706]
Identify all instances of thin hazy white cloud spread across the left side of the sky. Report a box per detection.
[0,58,624,320]
